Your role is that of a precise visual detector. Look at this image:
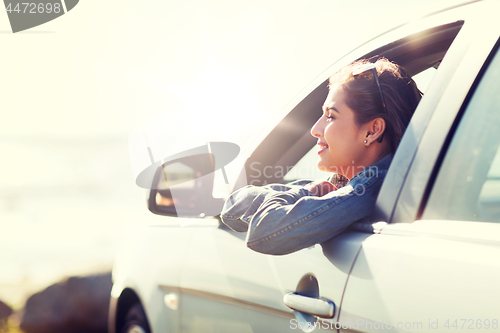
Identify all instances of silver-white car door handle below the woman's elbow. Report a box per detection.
[283,293,335,318]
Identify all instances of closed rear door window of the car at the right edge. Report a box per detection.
[422,42,500,222]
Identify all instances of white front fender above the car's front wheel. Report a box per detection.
[110,217,195,333]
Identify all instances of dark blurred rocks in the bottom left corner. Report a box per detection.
[0,273,112,333]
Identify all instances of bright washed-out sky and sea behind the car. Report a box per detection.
[0,0,456,308]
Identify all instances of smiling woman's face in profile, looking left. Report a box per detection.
[311,87,367,178]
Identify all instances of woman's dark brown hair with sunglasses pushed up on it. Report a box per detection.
[328,58,422,153]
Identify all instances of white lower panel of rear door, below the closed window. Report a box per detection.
[339,220,500,332]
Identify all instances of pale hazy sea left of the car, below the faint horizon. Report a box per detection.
[0,136,167,307]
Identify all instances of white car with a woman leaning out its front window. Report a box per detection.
[109,0,500,333]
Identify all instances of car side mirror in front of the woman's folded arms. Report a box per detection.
[148,153,224,217]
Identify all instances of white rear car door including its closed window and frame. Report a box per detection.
[339,13,500,332]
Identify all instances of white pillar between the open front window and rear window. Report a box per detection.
[392,12,500,223]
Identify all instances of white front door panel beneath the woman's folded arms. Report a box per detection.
[180,220,367,332]
